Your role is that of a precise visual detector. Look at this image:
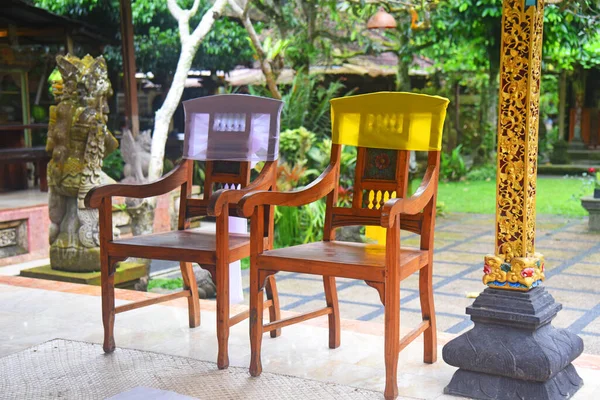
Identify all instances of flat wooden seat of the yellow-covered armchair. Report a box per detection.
[258,241,429,282]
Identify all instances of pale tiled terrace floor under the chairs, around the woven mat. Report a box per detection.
[0,276,600,400]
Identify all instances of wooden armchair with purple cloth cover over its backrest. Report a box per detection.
[85,95,283,369]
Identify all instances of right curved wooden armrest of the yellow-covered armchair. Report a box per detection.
[381,165,438,228]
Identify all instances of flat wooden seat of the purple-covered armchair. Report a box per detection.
[109,229,250,265]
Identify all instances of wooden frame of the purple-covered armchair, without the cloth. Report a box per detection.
[85,160,280,369]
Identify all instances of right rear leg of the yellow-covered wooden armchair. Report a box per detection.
[419,264,437,364]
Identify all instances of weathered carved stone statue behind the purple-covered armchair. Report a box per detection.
[46,54,118,272]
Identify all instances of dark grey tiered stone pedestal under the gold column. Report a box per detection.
[443,287,583,400]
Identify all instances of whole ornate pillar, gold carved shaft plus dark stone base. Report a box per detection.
[443,0,583,400]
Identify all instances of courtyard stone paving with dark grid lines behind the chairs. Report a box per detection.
[156,214,600,354]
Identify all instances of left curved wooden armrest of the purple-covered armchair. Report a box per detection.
[85,161,189,208]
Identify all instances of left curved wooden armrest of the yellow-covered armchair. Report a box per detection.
[238,164,338,218]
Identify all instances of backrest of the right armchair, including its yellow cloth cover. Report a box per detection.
[324,92,448,244]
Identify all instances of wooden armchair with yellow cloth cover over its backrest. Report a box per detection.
[238,93,448,399]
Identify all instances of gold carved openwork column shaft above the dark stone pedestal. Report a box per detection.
[483,0,544,291]
